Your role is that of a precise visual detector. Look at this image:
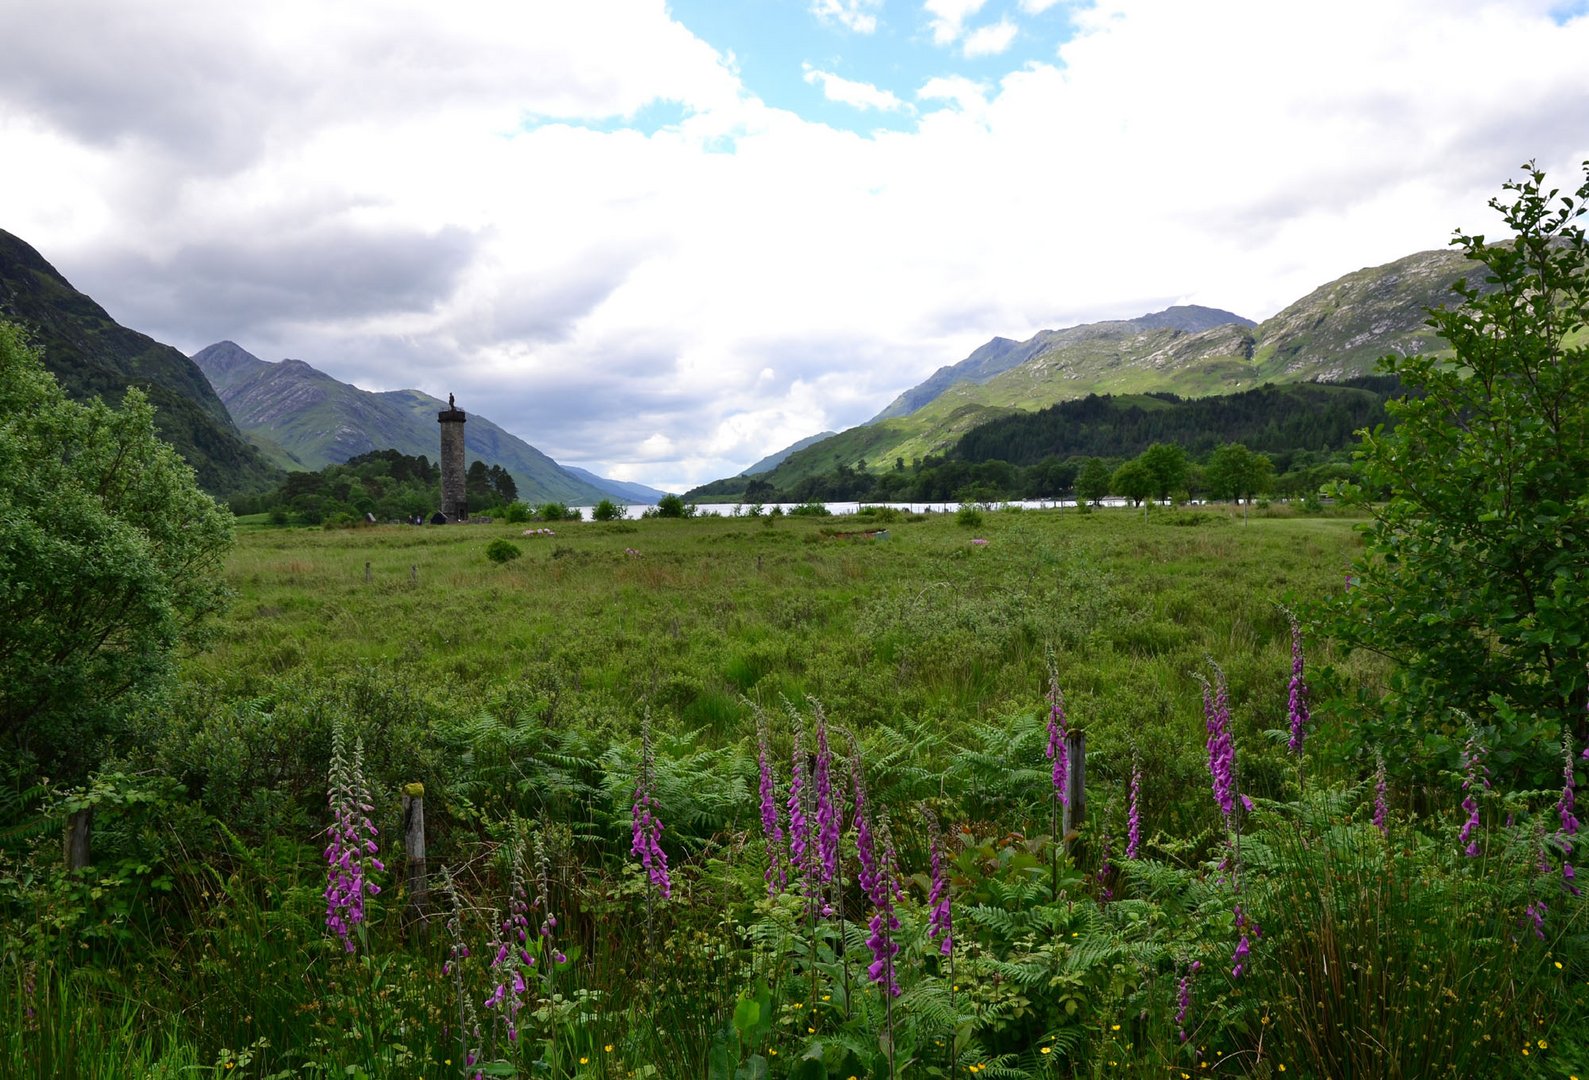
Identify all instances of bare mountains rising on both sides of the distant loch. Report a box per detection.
[0,222,1484,503]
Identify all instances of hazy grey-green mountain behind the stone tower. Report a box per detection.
[194,341,620,503]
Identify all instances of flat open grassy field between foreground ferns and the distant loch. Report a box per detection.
[192,508,1355,756]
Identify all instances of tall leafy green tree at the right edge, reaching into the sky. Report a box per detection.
[1322,162,1589,785]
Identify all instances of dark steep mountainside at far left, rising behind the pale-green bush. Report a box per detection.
[0,230,280,496]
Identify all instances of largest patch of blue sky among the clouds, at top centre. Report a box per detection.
[669,0,1074,133]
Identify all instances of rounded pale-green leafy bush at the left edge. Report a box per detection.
[0,322,232,780]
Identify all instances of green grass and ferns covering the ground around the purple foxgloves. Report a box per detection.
[0,508,1589,1080]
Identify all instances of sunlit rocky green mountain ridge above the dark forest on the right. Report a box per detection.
[691,244,1483,497]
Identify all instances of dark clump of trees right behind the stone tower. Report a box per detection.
[232,449,518,526]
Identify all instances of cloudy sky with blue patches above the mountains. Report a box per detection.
[0,0,1589,491]
